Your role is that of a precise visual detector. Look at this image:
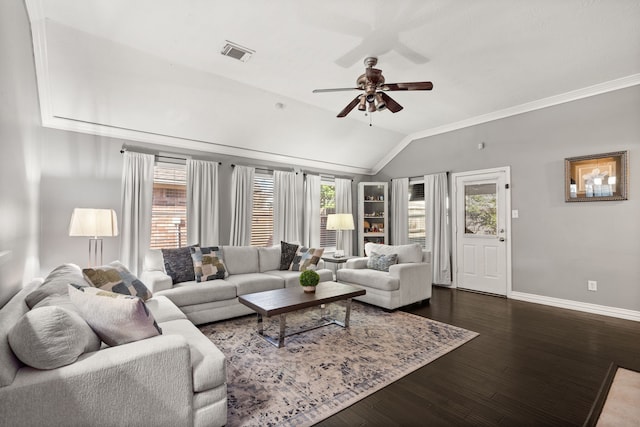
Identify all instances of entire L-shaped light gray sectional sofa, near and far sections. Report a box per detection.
[0,246,333,427]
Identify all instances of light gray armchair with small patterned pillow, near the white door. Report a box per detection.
[336,243,431,310]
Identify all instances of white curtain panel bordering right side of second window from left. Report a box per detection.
[273,171,300,243]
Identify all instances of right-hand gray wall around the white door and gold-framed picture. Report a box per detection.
[373,86,640,310]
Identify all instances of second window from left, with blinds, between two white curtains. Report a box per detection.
[251,172,280,246]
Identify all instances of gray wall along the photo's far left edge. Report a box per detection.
[0,0,42,306]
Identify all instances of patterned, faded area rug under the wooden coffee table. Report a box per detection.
[200,302,478,426]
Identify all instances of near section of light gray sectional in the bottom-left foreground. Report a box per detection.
[0,264,227,426]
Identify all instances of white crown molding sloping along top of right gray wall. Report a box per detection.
[372,73,640,175]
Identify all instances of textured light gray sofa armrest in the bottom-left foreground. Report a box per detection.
[0,335,193,426]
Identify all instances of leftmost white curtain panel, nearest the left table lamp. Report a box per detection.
[120,151,155,275]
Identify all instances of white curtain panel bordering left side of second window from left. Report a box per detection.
[229,165,256,246]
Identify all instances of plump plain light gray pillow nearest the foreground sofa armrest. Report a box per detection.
[8,306,100,369]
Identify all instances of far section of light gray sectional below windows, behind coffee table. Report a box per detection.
[140,246,333,325]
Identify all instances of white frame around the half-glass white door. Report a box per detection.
[451,166,512,298]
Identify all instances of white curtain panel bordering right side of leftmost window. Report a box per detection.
[187,159,220,246]
